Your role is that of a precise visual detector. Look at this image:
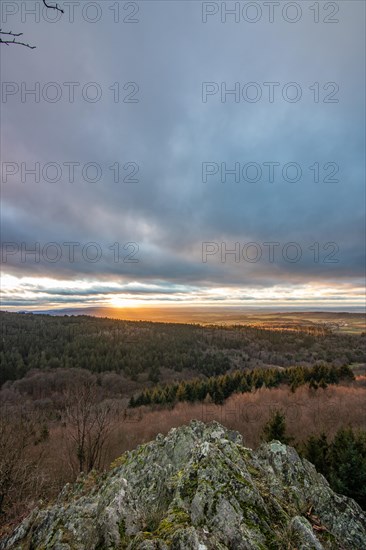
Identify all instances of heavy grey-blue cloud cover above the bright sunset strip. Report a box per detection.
[2,2,365,300]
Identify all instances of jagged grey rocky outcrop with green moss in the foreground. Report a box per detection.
[0,421,366,550]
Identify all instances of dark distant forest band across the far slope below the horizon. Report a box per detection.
[0,312,366,385]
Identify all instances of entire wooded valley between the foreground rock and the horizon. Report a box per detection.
[0,312,366,536]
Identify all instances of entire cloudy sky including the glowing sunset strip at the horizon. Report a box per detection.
[0,0,365,310]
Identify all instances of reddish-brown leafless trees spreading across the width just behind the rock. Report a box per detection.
[0,377,366,536]
